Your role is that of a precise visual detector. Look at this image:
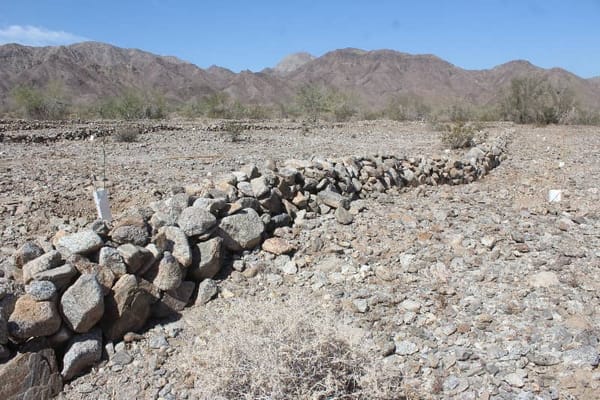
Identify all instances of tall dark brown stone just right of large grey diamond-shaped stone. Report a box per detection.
[101,274,159,341]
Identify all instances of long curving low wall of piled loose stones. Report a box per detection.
[0,133,507,398]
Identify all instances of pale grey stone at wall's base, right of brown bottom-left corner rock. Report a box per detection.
[61,329,102,381]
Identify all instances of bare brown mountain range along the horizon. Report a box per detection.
[0,42,600,109]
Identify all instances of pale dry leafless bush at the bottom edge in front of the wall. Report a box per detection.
[190,297,404,400]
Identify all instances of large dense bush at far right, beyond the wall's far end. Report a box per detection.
[501,76,575,125]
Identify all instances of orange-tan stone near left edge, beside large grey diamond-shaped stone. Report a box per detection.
[8,294,61,340]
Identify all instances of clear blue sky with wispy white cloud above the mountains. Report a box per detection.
[0,0,600,78]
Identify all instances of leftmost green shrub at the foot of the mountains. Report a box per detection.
[11,81,69,120]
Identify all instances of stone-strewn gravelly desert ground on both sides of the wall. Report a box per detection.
[0,120,600,399]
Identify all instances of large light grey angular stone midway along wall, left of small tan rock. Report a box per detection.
[218,209,265,251]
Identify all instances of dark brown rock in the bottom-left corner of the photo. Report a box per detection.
[0,348,62,400]
